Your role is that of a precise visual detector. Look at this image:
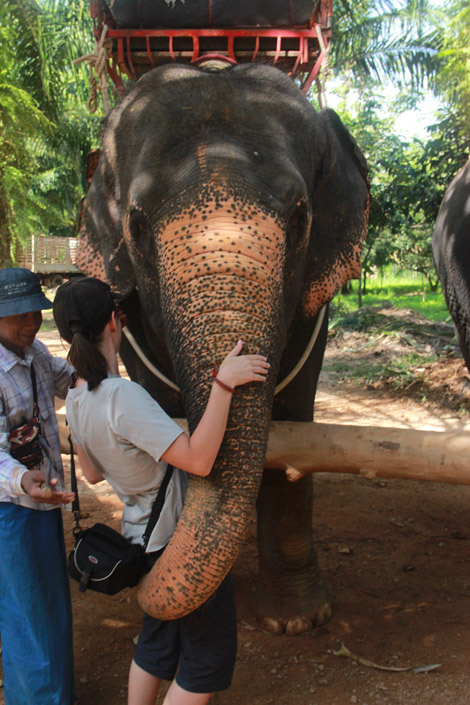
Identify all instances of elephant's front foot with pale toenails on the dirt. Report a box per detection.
[257,577,333,636]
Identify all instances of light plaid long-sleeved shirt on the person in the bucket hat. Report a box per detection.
[0,340,73,510]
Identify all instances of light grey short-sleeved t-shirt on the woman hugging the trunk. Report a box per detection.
[66,375,187,553]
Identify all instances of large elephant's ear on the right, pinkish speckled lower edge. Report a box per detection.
[302,110,370,318]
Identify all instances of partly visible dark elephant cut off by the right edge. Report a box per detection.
[432,160,470,371]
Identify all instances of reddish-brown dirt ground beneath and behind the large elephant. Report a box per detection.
[0,314,470,705]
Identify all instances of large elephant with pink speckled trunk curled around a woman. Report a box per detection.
[78,63,369,634]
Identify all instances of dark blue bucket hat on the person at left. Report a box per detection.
[0,267,52,318]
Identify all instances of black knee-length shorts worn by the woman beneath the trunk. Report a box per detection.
[134,573,237,693]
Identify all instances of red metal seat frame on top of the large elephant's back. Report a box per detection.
[90,0,333,93]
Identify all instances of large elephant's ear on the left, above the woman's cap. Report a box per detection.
[77,138,135,299]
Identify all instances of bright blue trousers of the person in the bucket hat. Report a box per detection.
[0,502,75,705]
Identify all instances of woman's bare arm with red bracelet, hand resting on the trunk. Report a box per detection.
[162,340,269,477]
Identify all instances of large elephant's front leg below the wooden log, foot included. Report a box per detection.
[257,470,333,635]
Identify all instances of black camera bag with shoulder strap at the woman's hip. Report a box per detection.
[68,437,173,595]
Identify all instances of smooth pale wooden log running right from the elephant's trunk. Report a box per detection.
[266,421,470,485]
